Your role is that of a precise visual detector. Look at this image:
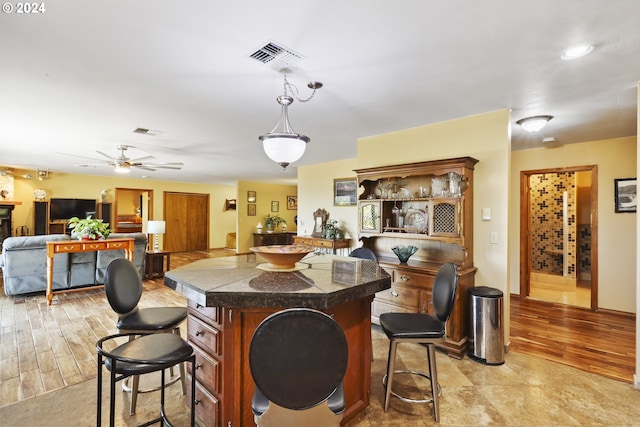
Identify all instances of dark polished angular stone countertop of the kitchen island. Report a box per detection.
[164,254,391,310]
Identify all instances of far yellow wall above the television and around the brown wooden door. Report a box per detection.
[13,170,236,248]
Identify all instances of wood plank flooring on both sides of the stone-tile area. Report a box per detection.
[0,250,635,412]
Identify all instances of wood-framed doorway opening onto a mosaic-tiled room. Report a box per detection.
[520,165,598,310]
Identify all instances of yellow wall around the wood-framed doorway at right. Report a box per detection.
[509,137,637,313]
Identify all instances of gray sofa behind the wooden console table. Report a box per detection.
[0,233,147,295]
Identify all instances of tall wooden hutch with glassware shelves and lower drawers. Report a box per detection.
[355,157,478,358]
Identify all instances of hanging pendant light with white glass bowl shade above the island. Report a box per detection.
[258,74,322,170]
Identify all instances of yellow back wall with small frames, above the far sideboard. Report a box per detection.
[236,181,299,254]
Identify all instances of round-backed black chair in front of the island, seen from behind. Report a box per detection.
[249,308,349,427]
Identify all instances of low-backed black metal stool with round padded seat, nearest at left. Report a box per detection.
[96,334,196,427]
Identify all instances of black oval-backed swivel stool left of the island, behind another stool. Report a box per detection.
[104,258,187,414]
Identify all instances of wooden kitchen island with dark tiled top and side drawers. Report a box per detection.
[165,254,391,427]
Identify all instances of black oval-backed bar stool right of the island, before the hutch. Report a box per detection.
[380,263,458,422]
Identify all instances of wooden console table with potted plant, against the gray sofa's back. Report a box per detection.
[47,239,135,305]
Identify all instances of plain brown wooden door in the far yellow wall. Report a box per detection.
[164,192,209,252]
